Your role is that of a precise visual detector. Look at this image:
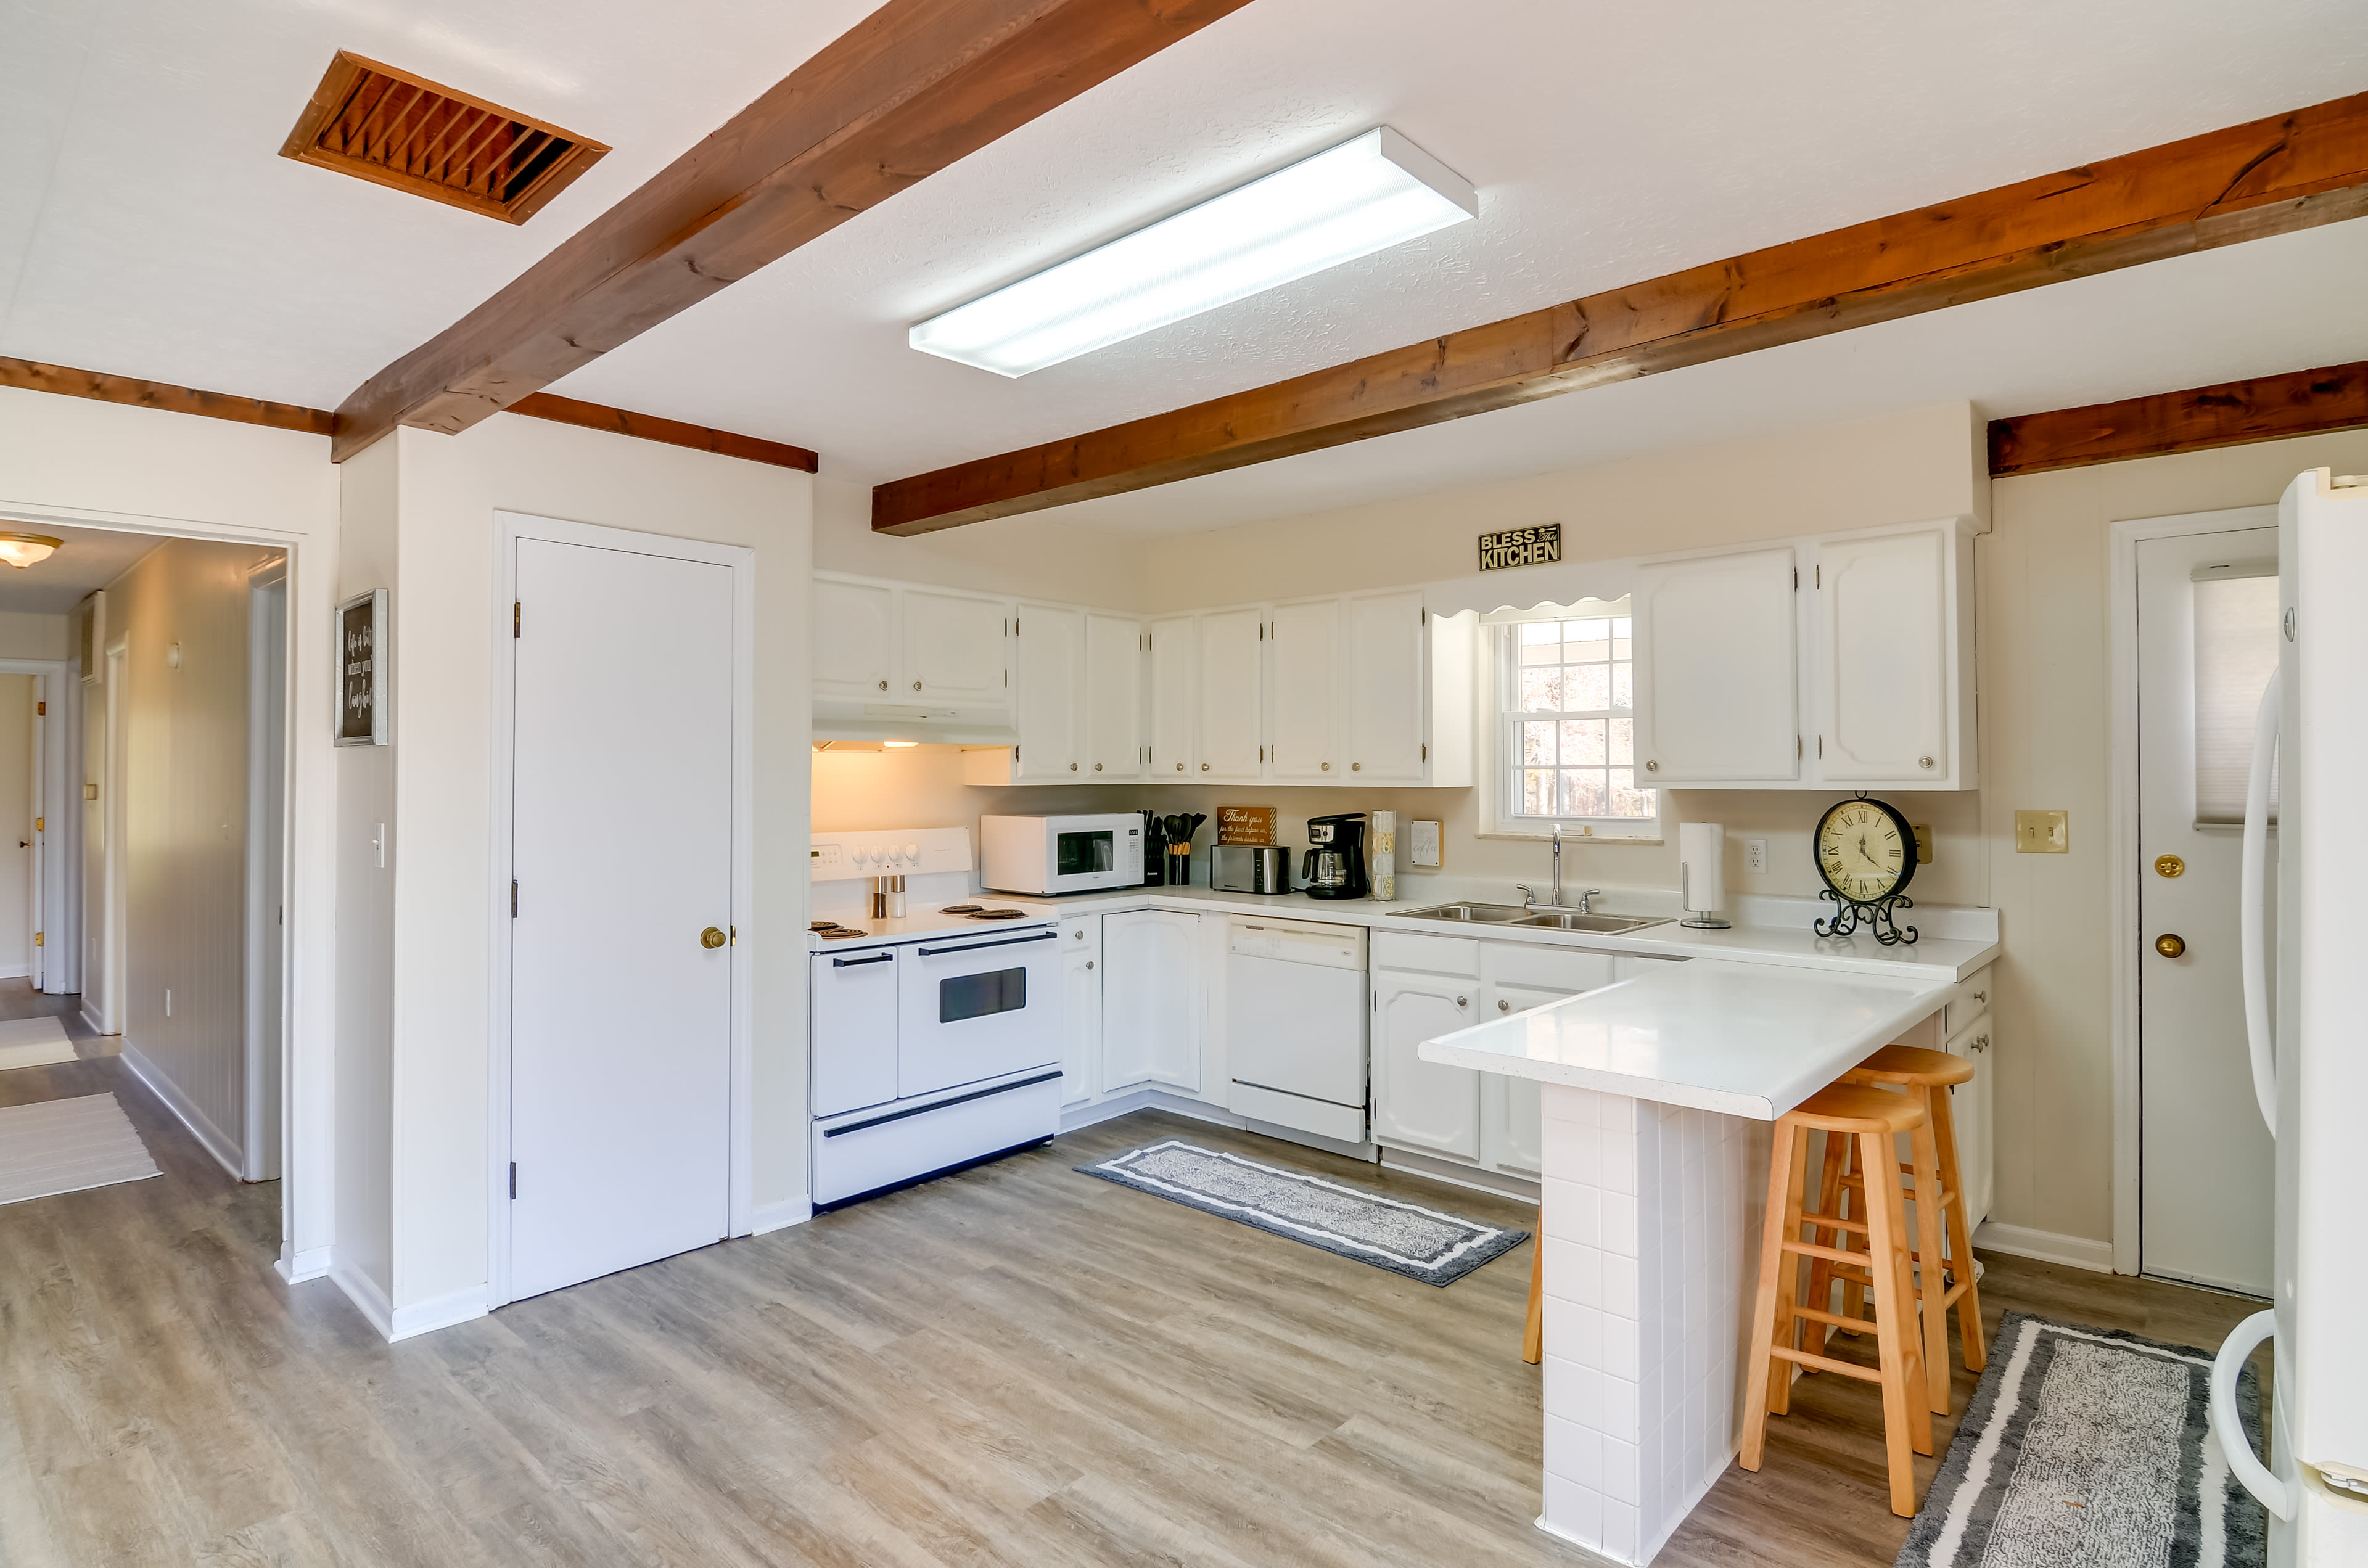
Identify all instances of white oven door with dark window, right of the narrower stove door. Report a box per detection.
[897,931,1061,1099]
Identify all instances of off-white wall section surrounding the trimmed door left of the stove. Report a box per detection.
[341,419,812,1321]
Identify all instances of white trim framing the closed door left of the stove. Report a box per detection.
[485,512,755,1307]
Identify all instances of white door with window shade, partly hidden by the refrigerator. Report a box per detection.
[2129,528,2278,1295]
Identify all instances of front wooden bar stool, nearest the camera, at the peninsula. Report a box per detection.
[1740,1083,1932,1518]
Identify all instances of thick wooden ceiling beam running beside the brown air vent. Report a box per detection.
[332,0,1248,462]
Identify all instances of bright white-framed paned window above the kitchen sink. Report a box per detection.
[1492,599,1660,839]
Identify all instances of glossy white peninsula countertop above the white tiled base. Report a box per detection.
[1418,959,1951,1120]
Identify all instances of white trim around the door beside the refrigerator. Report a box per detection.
[2105,504,2278,1275]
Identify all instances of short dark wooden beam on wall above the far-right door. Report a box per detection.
[1989,360,2368,478]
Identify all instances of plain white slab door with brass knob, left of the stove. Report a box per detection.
[509,538,734,1298]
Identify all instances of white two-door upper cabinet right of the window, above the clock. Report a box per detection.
[1634,519,1980,789]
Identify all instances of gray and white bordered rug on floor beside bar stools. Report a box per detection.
[1897,1312,2269,1568]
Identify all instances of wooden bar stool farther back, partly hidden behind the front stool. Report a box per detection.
[1809,1045,1987,1416]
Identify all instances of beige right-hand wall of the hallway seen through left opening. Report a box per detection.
[102,540,279,1175]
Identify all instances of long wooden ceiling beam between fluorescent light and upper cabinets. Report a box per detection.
[871,92,2368,533]
